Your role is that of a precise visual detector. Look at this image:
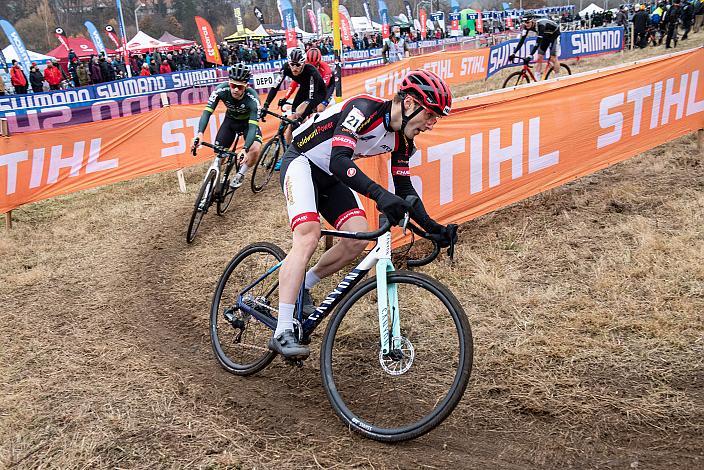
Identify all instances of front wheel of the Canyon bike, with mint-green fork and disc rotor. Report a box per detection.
[320,271,472,442]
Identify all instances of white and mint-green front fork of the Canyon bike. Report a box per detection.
[376,232,401,355]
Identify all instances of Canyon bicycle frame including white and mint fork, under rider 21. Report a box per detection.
[237,230,401,354]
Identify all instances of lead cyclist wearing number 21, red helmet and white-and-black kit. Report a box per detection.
[269,70,454,359]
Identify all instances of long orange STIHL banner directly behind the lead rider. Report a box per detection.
[0,48,704,223]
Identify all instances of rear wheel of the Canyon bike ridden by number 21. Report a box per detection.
[210,242,286,375]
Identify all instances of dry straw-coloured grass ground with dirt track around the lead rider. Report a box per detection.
[0,43,704,469]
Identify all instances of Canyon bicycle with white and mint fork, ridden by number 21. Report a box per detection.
[210,213,473,442]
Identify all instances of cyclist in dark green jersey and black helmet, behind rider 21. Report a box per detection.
[193,64,262,188]
